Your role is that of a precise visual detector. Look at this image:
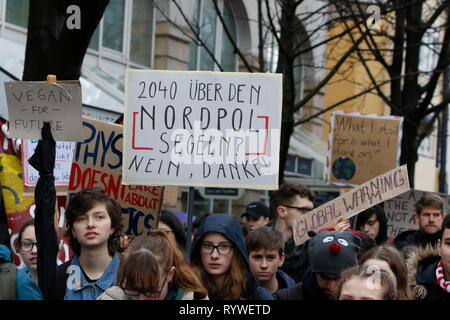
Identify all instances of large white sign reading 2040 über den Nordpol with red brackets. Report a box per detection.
[122,70,282,189]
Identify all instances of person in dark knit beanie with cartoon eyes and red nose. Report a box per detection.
[273,228,361,300]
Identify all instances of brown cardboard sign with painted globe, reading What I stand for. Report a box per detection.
[325,111,403,186]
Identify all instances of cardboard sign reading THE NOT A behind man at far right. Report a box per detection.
[384,190,450,238]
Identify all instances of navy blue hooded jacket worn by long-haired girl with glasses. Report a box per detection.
[190,214,273,300]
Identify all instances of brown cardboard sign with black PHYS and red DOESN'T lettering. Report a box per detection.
[69,117,164,236]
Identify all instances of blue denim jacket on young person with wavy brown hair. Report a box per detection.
[64,254,120,300]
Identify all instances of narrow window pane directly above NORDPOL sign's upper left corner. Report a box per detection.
[130,0,153,67]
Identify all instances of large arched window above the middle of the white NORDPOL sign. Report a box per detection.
[189,0,237,71]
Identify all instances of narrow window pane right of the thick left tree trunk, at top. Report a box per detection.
[102,0,125,52]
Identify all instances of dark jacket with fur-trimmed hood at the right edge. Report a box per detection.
[404,246,450,300]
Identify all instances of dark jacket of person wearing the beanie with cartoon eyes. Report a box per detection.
[273,268,329,300]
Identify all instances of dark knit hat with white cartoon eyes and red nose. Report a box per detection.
[308,228,361,276]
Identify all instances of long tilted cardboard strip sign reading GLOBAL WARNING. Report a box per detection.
[292,165,409,245]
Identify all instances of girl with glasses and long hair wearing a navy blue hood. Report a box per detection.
[191,214,273,300]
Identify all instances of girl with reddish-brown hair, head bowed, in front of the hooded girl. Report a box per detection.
[98,229,208,300]
